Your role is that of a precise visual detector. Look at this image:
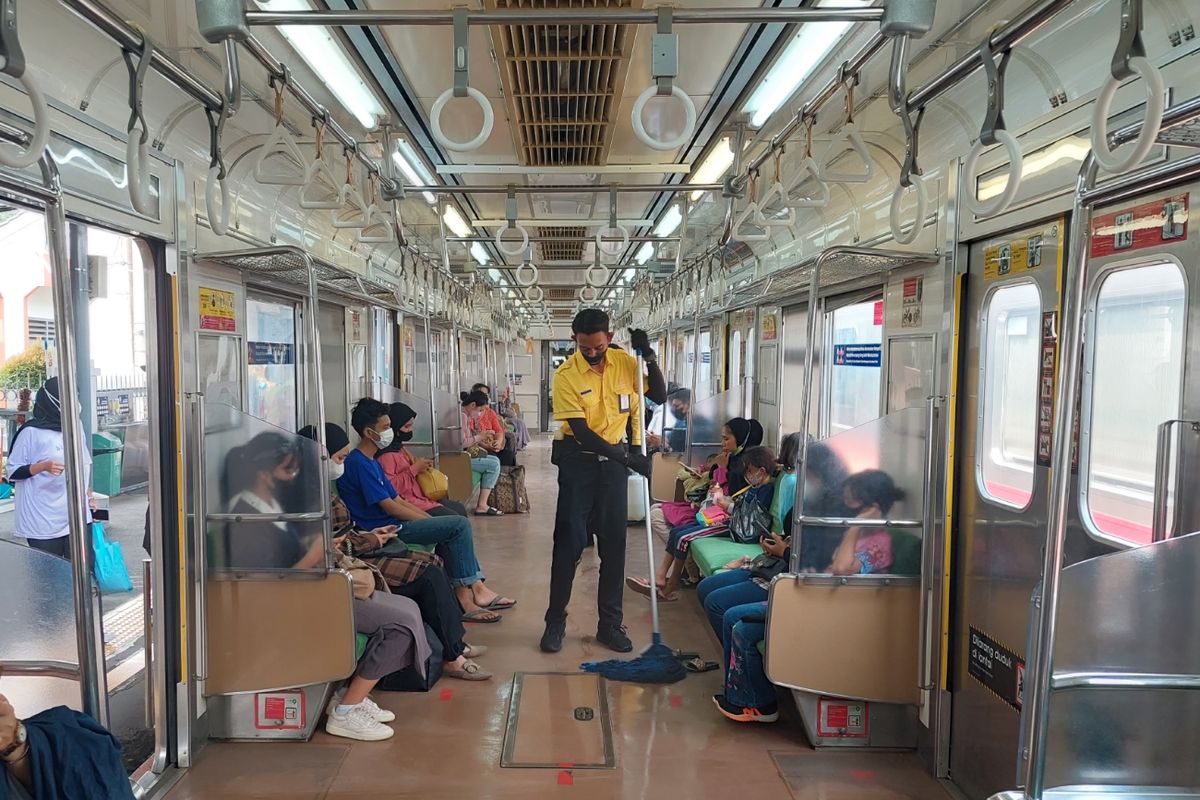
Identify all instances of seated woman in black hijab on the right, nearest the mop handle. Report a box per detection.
[625,416,762,600]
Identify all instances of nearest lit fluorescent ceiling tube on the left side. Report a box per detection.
[258,0,384,131]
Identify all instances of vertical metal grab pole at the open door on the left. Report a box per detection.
[40,155,108,727]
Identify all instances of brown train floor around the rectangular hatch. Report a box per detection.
[167,439,947,800]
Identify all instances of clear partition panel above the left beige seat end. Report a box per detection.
[203,403,328,572]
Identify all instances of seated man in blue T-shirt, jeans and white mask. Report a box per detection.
[337,397,516,612]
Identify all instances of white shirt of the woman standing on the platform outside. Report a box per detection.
[7,428,91,540]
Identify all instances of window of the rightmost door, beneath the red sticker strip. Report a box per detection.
[1080,261,1187,545]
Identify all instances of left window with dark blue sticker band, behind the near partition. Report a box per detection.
[246,297,299,431]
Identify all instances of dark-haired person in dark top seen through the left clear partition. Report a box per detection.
[222,431,325,570]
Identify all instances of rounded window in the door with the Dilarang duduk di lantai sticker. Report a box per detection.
[978,283,1042,509]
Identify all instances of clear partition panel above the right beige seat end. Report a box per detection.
[793,408,929,575]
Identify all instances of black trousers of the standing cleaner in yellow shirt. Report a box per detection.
[546,451,629,628]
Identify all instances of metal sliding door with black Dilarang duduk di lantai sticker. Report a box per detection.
[949,219,1066,798]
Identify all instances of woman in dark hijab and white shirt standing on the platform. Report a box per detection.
[7,378,91,560]
